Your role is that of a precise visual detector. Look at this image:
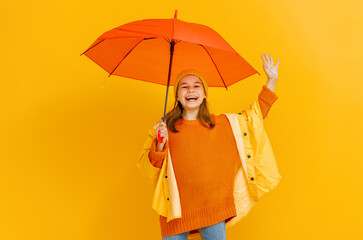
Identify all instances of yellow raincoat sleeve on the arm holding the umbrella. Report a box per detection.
[137,128,161,189]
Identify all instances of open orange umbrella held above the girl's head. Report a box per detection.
[81,10,261,142]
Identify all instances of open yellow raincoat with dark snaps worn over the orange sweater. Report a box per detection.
[137,99,281,240]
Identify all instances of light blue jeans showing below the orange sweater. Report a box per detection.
[162,220,226,240]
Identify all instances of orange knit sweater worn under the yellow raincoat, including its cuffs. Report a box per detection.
[149,86,277,236]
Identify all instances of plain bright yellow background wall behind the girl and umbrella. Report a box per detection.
[0,0,363,240]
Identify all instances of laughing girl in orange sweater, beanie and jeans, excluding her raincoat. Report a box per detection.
[139,54,280,240]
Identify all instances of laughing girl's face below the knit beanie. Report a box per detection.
[177,75,206,110]
